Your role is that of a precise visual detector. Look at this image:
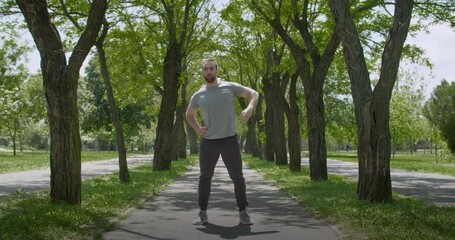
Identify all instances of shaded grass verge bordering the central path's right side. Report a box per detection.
[244,156,455,240]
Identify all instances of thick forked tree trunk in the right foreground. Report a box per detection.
[330,0,413,202]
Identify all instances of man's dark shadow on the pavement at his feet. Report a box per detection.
[196,223,279,239]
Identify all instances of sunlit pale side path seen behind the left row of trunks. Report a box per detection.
[0,155,152,196]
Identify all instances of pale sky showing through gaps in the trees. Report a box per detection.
[24,20,455,98]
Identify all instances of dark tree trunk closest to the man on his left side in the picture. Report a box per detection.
[153,42,182,171]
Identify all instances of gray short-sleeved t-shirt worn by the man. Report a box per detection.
[190,79,246,139]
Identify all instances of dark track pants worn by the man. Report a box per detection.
[198,135,248,210]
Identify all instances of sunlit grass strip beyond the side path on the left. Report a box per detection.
[0,150,140,174]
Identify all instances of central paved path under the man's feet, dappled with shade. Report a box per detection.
[104,160,341,240]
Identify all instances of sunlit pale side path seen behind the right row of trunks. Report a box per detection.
[302,158,455,206]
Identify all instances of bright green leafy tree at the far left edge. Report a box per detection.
[0,33,45,153]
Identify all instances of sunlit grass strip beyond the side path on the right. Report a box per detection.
[327,151,455,176]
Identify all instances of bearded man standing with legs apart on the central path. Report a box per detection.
[186,59,259,225]
